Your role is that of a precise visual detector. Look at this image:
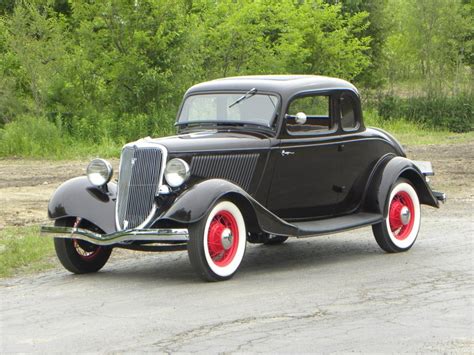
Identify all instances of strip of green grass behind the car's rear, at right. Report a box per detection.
[364,110,474,146]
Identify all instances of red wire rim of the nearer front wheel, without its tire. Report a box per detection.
[207,211,239,267]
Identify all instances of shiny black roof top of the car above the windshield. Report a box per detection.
[186,75,358,96]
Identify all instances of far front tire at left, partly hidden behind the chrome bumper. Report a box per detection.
[54,220,112,274]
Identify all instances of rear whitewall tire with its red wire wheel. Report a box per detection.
[372,179,421,253]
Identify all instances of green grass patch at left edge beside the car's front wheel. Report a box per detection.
[0,226,54,277]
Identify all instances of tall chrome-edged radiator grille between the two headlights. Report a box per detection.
[116,146,163,229]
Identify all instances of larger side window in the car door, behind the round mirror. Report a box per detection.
[286,95,332,135]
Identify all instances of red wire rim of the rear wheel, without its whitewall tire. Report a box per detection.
[388,191,415,240]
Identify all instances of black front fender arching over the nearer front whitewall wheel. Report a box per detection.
[159,179,297,236]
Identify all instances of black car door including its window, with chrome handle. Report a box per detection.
[267,93,339,219]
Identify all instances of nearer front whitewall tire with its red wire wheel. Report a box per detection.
[188,200,247,281]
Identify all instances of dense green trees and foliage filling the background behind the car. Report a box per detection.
[0,0,474,155]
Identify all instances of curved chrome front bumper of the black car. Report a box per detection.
[40,226,189,245]
